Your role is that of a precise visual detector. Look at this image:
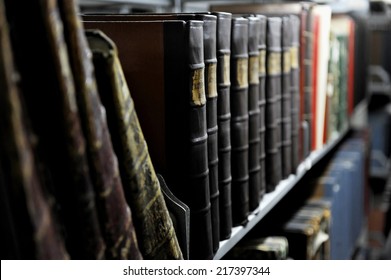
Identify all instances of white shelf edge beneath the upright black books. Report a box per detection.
[214,129,348,260]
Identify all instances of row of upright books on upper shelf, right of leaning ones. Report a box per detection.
[82,2,368,259]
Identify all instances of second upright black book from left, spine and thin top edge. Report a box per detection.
[84,13,220,252]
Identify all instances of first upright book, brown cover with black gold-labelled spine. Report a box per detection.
[84,20,213,259]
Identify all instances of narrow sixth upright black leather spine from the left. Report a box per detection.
[257,15,267,199]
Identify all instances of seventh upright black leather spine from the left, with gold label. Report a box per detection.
[265,17,281,192]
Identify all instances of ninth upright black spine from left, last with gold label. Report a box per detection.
[290,15,300,173]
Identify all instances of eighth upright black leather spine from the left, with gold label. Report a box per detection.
[281,16,292,179]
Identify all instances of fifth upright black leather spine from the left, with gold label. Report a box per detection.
[247,16,261,211]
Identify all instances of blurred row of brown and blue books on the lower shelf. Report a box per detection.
[224,131,370,260]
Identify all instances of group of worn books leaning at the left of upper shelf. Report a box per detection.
[0,0,183,259]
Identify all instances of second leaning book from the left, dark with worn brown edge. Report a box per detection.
[5,1,105,259]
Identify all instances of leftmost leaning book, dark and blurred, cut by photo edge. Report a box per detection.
[0,1,69,260]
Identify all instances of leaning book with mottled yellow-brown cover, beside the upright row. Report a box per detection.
[88,29,182,259]
